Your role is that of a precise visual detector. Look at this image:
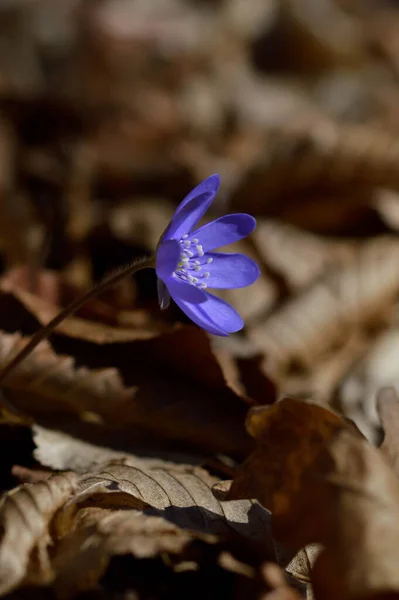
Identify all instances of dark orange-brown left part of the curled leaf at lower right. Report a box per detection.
[227,398,359,510]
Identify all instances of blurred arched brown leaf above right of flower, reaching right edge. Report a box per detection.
[233,117,399,232]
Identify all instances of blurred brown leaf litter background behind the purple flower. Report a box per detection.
[0,0,399,435]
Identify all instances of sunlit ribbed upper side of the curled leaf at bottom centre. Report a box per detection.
[69,460,274,553]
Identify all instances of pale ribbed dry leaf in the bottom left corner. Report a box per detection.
[0,473,77,594]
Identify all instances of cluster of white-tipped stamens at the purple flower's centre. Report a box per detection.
[173,234,213,290]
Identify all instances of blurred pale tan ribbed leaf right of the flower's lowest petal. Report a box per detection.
[250,238,399,370]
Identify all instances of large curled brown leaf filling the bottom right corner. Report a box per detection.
[229,400,399,600]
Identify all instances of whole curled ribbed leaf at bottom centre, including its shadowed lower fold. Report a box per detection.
[46,458,277,592]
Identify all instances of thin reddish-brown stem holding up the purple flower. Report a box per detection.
[0,256,155,383]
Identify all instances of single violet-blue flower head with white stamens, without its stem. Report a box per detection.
[156,175,260,336]
